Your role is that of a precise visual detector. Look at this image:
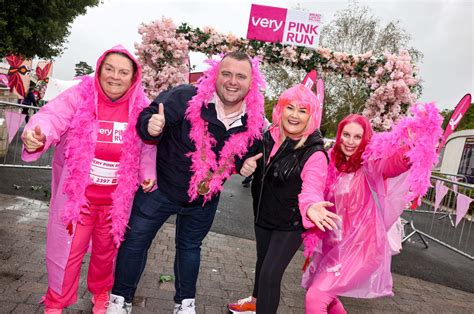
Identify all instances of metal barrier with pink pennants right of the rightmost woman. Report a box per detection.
[402,176,474,260]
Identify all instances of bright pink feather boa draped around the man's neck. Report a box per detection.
[186,58,265,202]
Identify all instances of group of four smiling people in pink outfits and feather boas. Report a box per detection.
[22,46,440,313]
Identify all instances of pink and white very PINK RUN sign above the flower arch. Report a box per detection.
[247,4,321,48]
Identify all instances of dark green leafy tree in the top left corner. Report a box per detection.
[0,0,100,59]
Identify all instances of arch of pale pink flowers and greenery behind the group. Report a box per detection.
[135,17,419,130]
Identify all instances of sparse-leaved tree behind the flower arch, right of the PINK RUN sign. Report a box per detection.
[312,1,423,137]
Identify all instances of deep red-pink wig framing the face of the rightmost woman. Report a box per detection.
[331,114,374,172]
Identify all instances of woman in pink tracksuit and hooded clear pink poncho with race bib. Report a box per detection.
[22,46,155,313]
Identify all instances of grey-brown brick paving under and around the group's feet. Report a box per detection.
[0,194,474,314]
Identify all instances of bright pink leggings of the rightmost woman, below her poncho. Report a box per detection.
[305,286,347,314]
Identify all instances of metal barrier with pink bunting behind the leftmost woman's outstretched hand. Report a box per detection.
[0,101,53,169]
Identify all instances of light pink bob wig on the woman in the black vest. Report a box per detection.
[272,84,322,136]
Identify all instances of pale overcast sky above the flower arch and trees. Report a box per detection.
[53,0,474,109]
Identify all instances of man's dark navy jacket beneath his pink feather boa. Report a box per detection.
[137,85,256,206]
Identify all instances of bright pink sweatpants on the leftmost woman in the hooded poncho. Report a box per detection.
[44,205,117,309]
